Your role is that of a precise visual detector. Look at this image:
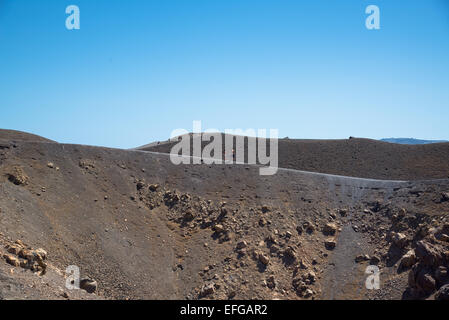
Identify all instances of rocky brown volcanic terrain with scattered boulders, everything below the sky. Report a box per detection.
[0,130,449,299]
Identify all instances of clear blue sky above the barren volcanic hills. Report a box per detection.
[0,0,449,148]
